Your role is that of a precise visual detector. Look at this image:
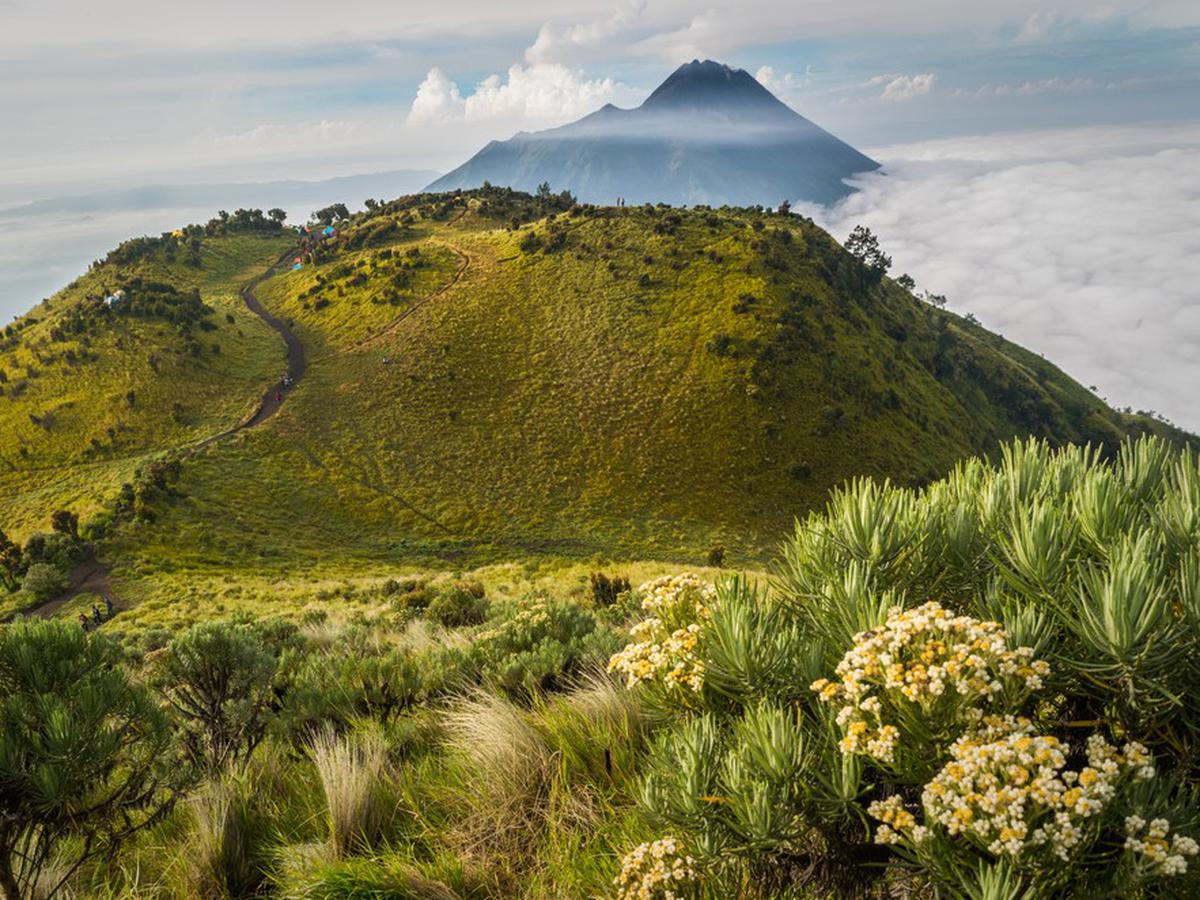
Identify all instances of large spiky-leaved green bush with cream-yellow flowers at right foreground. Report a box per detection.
[613,439,1200,899]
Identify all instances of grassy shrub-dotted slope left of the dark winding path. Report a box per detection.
[0,227,292,536]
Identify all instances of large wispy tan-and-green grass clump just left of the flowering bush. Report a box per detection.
[443,676,644,896]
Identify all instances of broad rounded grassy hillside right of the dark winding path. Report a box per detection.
[98,190,1185,578]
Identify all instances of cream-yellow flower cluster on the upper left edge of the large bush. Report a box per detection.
[608,574,716,694]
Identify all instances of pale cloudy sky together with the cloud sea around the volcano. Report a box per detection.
[7,0,1200,428]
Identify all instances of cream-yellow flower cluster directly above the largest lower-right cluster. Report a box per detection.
[811,601,1050,763]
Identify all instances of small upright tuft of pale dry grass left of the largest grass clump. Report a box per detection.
[312,731,386,858]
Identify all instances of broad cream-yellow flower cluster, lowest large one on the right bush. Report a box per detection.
[869,716,1154,860]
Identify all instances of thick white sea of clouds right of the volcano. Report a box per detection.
[815,125,1200,430]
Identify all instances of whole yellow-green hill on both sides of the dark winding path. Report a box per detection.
[0,188,1185,609]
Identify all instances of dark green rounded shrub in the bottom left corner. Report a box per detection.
[0,619,179,900]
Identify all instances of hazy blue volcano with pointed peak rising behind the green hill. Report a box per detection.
[427,60,878,206]
